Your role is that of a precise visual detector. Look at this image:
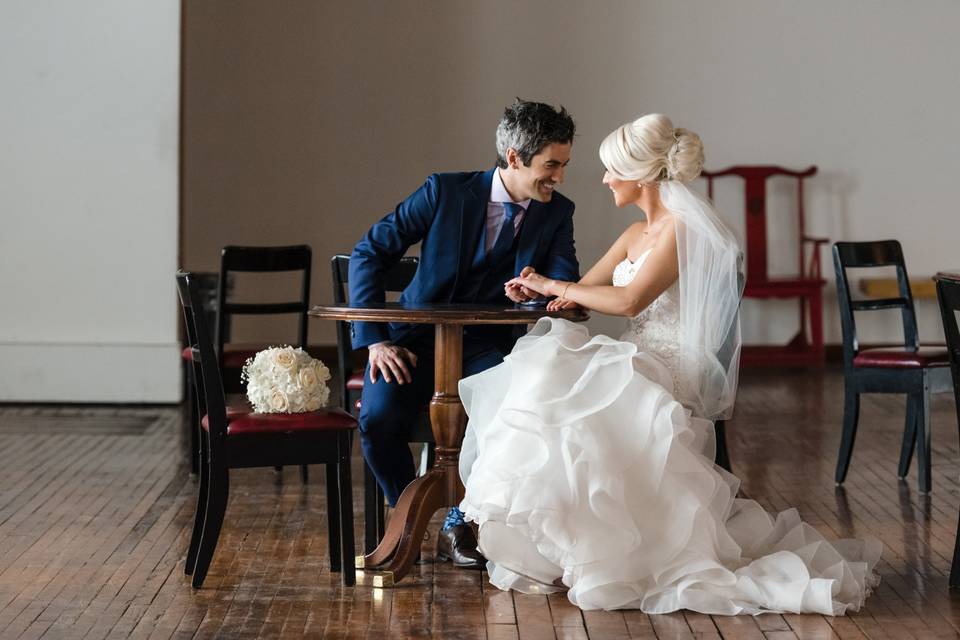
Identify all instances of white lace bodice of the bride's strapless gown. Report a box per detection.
[613,250,684,401]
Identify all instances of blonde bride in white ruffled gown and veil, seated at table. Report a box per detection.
[460,114,881,615]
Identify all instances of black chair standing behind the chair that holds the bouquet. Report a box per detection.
[181,245,313,482]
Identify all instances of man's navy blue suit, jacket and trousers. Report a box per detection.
[349,169,579,504]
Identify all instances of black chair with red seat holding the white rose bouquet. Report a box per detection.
[177,271,357,587]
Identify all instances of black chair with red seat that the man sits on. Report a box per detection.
[330,254,434,553]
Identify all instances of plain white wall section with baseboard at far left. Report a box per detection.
[0,0,179,402]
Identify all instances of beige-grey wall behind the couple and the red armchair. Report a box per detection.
[182,0,960,350]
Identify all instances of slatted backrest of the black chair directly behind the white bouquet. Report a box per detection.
[215,244,313,364]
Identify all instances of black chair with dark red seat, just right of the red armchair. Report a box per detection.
[833,240,949,493]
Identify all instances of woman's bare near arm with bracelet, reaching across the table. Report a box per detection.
[518,225,679,317]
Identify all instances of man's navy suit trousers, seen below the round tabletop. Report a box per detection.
[360,327,505,506]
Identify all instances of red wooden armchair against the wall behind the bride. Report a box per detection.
[703,165,829,366]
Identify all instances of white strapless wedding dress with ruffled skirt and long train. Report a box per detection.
[460,254,881,615]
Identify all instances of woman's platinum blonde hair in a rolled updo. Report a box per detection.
[600,113,703,184]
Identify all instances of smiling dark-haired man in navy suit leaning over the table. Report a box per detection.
[349,99,579,569]
